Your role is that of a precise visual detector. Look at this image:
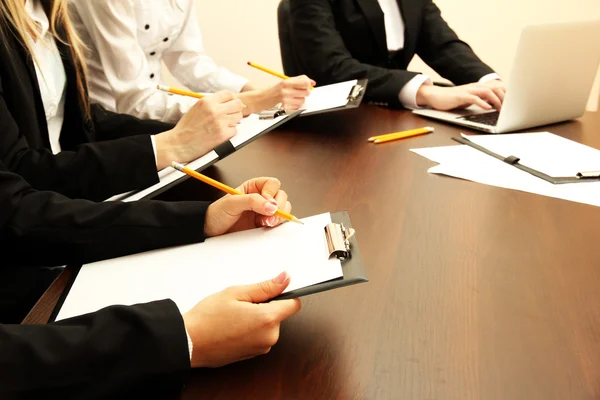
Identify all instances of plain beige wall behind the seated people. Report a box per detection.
[165,0,600,111]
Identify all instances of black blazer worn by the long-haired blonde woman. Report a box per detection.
[0,23,172,200]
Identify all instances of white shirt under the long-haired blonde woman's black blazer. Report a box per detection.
[25,0,67,154]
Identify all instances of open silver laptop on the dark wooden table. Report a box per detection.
[413,20,600,133]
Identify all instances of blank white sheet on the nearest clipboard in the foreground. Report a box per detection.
[57,213,343,320]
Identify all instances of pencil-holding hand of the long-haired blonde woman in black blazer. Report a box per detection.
[155,91,244,170]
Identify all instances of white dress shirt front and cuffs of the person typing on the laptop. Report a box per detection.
[377,0,500,108]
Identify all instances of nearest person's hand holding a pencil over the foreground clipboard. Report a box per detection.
[204,178,292,237]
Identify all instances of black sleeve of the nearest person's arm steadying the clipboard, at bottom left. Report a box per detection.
[0,300,190,399]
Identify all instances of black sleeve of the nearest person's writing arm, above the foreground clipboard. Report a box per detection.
[0,164,208,266]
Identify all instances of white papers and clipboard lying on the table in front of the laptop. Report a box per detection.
[411,132,600,206]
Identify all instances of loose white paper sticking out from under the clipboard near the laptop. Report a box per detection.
[411,145,600,207]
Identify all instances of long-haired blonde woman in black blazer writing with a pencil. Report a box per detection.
[0,0,244,201]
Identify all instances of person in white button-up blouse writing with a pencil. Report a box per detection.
[70,0,315,122]
